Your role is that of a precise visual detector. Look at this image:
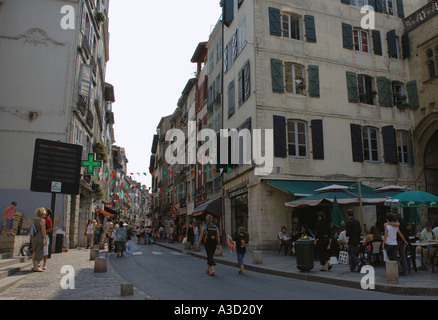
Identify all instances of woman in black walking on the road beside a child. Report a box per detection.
[198,214,221,276]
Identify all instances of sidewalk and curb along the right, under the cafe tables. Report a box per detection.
[158,242,438,296]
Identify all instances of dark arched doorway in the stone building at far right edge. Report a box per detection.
[424,130,438,223]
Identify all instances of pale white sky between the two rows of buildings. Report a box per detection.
[106,0,222,187]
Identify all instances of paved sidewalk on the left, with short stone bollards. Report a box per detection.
[0,248,150,300]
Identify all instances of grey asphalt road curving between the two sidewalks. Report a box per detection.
[109,241,434,301]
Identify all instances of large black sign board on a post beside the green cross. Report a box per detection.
[30,139,82,194]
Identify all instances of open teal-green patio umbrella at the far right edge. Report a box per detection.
[385,190,438,208]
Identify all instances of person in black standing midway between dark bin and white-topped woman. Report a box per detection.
[345,209,362,272]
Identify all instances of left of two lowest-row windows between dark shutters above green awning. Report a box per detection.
[287,119,307,158]
